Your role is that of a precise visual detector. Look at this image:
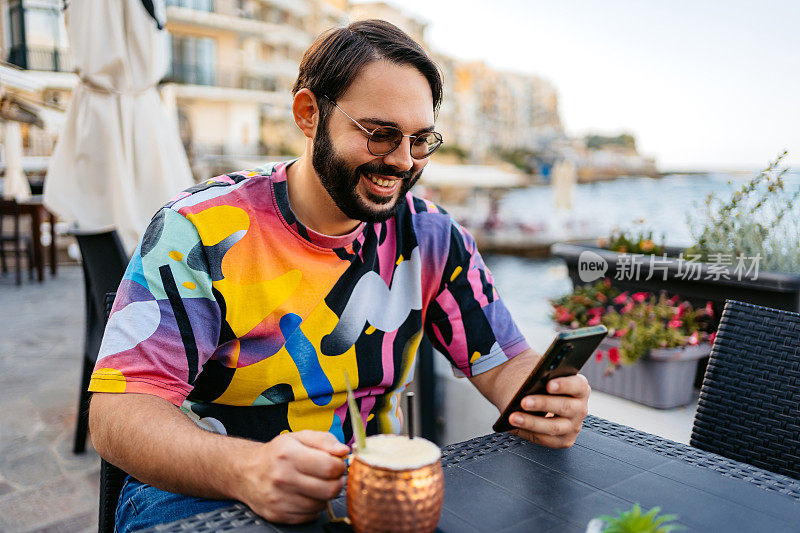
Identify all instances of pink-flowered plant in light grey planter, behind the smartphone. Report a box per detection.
[551,278,715,409]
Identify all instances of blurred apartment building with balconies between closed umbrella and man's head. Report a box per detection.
[163,0,346,177]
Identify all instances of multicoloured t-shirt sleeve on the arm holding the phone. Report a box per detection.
[425,219,529,377]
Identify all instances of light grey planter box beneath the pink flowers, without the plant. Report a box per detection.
[581,338,711,409]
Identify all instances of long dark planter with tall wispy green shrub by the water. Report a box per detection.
[551,152,800,316]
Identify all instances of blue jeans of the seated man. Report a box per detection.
[114,476,234,533]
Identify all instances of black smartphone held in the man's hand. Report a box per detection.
[492,326,608,432]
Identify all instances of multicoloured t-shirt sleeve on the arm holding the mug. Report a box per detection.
[89,207,221,405]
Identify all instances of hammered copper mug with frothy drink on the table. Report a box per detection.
[328,435,444,533]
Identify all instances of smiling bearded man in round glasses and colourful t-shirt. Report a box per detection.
[89,20,589,531]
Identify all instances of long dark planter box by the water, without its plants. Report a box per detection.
[550,242,800,317]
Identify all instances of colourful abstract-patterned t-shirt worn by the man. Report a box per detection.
[89,163,528,443]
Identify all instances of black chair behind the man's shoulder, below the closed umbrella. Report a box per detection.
[72,231,128,453]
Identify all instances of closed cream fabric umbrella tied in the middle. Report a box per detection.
[44,0,193,252]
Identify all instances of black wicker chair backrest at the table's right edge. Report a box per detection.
[690,300,800,479]
